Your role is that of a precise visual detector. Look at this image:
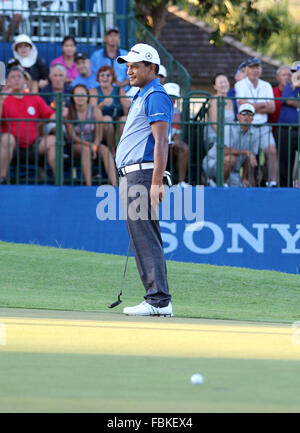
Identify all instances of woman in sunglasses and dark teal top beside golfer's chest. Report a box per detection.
[90,65,131,155]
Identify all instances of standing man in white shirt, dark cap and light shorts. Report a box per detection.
[235,57,277,187]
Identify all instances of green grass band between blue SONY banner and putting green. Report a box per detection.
[0,242,300,323]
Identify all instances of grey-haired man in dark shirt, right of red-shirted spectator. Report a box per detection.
[40,63,72,134]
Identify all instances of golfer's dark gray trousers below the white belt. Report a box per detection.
[120,169,171,307]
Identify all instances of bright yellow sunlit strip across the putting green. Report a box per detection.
[0,317,300,360]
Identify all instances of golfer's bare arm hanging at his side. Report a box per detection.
[151,121,169,185]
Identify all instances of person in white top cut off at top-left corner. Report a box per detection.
[0,0,28,41]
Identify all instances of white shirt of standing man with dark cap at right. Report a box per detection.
[234,77,274,124]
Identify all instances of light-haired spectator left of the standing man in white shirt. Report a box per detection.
[204,74,235,154]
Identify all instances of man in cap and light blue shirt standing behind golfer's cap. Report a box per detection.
[91,27,129,92]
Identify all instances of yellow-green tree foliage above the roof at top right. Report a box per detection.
[135,0,300,63]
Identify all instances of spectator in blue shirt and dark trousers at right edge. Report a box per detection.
[278,61,300,187]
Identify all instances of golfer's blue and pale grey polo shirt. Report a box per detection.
[116,78,173,169]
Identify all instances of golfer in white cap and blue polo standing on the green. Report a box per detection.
[116,44,173,316]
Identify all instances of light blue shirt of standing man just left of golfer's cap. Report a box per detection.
[91,47,130,91]
